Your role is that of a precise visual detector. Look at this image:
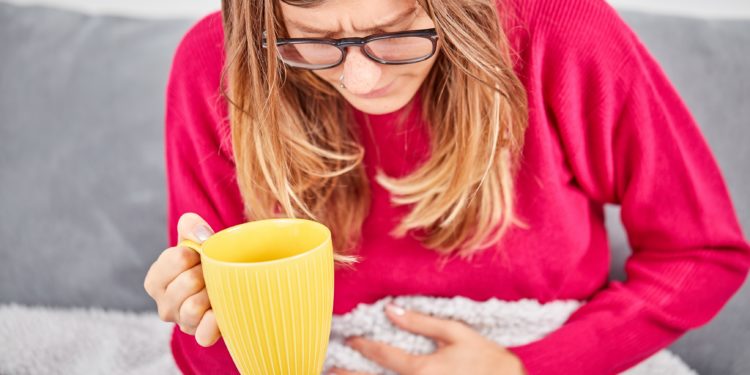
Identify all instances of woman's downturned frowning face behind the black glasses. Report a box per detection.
[281,0,438,114]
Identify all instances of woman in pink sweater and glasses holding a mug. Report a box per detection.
[144,0,750,374]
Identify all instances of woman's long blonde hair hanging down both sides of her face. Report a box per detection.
[222,0,527,263]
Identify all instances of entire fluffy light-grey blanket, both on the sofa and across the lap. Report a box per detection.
[0,296,696,375]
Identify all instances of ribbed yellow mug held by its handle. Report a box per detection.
[179,218,333,375]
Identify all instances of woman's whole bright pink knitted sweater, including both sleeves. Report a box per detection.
[166,0,750,375]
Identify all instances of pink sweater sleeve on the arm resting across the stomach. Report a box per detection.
[508,0,750,375]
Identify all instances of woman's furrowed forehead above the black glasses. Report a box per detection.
[280,0,417,31]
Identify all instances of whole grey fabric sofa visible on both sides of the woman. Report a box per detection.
[0,3,750,375]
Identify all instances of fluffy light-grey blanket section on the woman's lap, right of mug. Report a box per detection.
[324,296,697,375]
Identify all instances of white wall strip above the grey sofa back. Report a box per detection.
[0,0,750,19]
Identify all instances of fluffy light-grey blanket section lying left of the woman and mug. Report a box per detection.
[0,305,180,375]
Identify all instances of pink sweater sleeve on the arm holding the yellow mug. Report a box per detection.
[165,14,245,246]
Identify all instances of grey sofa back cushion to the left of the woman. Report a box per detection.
[0,3,193,310]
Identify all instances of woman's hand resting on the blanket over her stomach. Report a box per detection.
[330,305,526,375]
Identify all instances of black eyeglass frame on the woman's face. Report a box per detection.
[261,28,438,70]
